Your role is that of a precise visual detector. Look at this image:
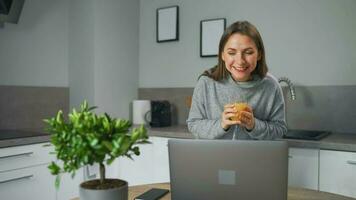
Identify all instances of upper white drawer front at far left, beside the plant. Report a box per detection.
[0,143,54,172]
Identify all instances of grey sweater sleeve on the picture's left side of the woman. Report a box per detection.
[187,77,228,139]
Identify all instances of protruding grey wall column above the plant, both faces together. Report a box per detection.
[69,0,139,118]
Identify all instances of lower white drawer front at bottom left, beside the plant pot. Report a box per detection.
[0,165,55,200]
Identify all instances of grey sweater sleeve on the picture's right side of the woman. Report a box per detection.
[245,87,287,140]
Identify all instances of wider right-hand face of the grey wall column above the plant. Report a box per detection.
[94,0,139,118]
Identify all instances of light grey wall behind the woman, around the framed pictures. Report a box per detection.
[139,0,356,88]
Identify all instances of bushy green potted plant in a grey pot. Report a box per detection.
[44,101,149,200]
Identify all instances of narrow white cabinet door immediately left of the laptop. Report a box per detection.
[152,137,170,183]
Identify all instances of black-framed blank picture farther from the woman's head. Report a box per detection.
[156,6,179,42]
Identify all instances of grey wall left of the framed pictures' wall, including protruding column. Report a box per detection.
[0,0,140,118]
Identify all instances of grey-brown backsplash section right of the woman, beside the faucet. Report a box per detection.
[283,86,356,134]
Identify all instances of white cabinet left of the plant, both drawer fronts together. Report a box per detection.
[0,143,56,200]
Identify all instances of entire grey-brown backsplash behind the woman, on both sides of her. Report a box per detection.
[138,86,356,134]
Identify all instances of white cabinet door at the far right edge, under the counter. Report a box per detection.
[320,150,356,198]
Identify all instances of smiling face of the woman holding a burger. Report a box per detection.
[221,33,260,81]
